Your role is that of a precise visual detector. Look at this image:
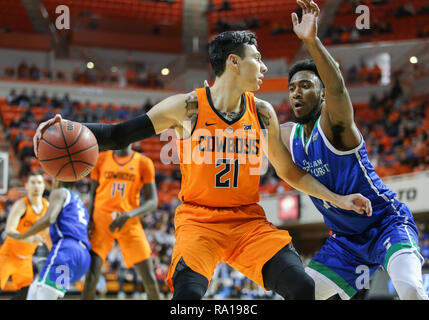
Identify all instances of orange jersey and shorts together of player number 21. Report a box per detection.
[167,88,291,288]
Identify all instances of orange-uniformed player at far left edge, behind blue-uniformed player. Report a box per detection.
[0,173,48,300]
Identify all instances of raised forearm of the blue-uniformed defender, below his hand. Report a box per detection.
[304,38,345,94]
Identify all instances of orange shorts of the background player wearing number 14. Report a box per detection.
[90,209,152,268]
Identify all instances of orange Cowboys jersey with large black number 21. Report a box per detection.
[177,88,263,207]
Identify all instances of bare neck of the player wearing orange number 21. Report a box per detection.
[210,76,243,113]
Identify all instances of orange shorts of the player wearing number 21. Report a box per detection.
[167,204,292,292]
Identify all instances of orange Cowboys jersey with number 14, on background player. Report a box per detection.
[91,151,155,212]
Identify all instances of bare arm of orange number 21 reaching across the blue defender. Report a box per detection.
[255,98,372,215]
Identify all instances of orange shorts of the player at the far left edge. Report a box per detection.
[0,250,33,290]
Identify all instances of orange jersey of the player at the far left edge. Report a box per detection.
[2,197,49,257]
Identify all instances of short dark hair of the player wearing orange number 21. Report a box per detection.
[209,30,257,77]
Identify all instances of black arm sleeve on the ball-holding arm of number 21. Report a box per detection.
[83,114,155,151]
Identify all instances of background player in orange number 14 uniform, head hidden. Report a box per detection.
[82,145,159,299]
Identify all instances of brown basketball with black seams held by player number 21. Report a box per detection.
[38,120,98,181]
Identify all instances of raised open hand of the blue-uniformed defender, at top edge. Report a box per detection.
[292,0,320,41]
